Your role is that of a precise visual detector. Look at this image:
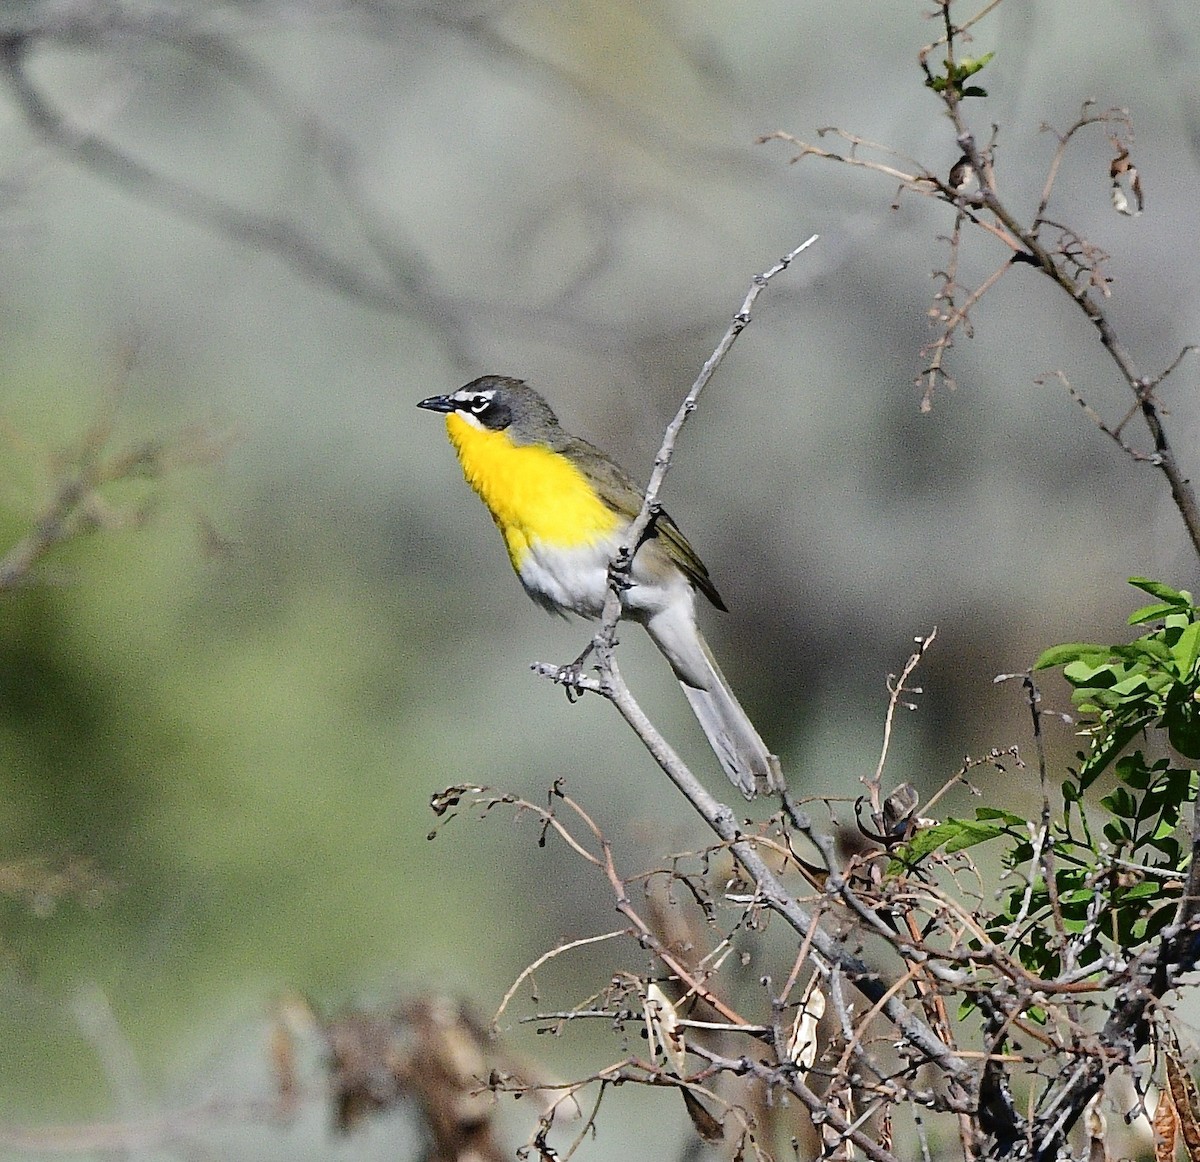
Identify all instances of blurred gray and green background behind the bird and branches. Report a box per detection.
[0,0,1200,1158]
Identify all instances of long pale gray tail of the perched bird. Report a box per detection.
[646,617,786,799]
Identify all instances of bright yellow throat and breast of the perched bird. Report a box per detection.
[446,413,619,573]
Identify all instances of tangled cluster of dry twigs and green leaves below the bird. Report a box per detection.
[433,600,1200,1162]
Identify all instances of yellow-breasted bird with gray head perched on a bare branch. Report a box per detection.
[418,375,785,799]
